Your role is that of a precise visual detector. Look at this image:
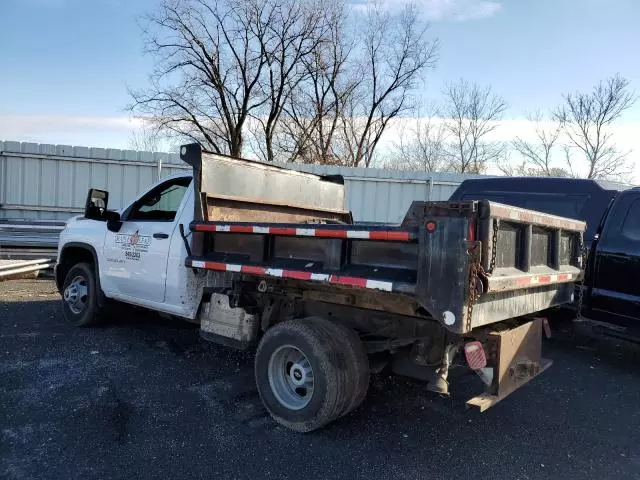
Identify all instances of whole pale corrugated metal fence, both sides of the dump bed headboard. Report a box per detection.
[0,141,480,222]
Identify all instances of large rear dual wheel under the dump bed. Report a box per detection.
[255,317,369,432]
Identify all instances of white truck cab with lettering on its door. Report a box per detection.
[55,175,197,325]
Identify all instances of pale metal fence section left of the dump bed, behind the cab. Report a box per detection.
[0,141,191,220]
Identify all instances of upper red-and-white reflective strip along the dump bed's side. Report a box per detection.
[193,223,415,242]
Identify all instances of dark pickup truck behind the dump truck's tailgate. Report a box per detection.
[451,178,640,341]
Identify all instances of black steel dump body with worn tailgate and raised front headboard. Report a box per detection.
[183,145,585,334]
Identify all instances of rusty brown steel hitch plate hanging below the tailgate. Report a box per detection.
[467,318,552,412]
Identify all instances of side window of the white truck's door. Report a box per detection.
[127,178,191,222]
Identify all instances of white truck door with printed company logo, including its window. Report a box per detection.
[100,177,191,302]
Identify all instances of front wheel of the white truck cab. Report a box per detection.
[62,262,101,327]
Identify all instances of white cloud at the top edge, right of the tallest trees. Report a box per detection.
[352,0,502,22]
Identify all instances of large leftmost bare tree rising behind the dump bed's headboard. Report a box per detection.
[130,0,323,160]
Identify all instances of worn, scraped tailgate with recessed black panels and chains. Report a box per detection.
[467,201,586,329]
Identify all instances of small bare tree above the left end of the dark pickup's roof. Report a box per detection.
[443,79,507,173]
